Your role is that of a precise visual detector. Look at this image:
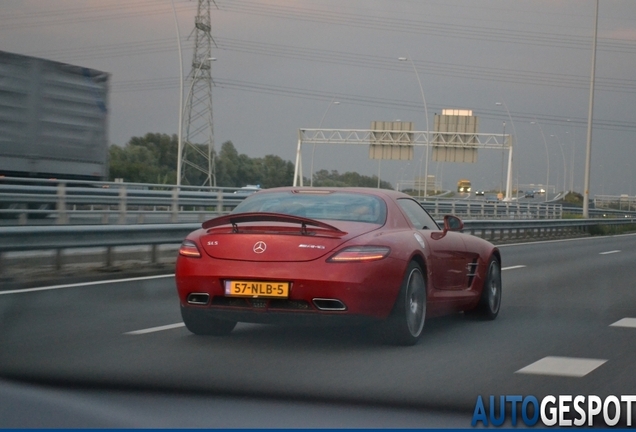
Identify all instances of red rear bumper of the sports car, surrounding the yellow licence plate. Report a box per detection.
[176,257,404,322]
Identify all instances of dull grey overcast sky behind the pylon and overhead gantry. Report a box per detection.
[0,0,636,195]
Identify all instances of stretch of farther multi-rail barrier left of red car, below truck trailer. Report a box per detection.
[0,178,251,225]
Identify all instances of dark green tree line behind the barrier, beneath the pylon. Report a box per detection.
[109,133,392,189]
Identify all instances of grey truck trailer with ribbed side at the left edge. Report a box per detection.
[0,51,110,181]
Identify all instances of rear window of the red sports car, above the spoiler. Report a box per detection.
[232,191,386,225]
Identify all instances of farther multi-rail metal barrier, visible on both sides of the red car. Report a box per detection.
[0,179,563,225]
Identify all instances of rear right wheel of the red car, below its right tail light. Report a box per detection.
[384,262,426,345]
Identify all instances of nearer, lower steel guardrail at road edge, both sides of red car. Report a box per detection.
[0,218,636,273]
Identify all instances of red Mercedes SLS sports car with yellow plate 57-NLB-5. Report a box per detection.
[176,187,502,345]
